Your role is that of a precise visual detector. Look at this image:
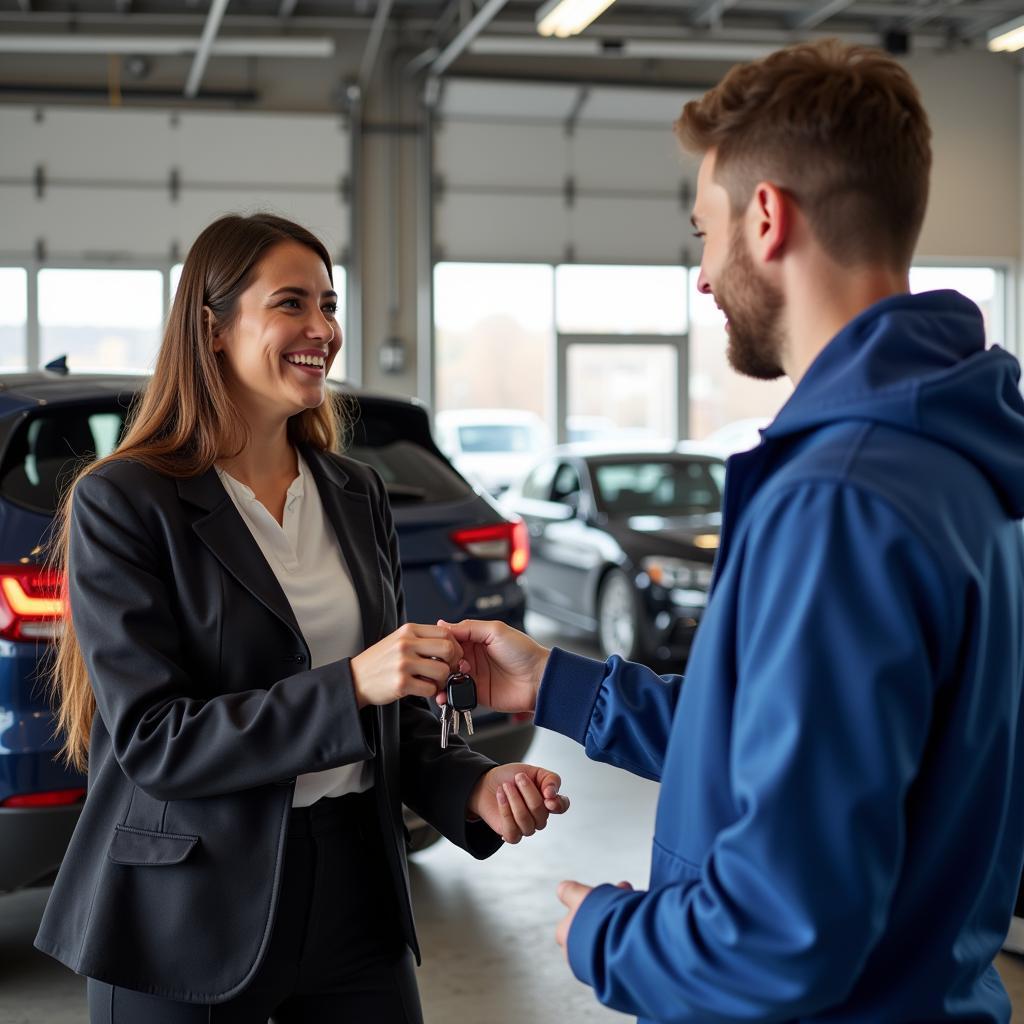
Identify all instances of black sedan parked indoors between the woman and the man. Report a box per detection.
[503,445,725,666]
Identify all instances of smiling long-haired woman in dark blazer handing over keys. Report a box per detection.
[36,214,567,1024]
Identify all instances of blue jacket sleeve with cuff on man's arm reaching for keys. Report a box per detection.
[535,647,683,782]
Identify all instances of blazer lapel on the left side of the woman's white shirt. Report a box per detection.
[178,468,304,643]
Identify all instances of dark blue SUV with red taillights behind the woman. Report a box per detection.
[0,371,534,892]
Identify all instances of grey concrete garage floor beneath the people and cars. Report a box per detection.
[6,620,1024,1024]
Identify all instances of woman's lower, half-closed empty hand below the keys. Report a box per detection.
[466,764,569,844]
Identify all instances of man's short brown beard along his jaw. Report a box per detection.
[715,224,785,381]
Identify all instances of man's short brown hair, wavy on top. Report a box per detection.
[675,39,932,268]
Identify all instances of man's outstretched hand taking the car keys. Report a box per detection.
[437,618,551,712]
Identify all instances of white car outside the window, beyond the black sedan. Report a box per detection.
[434,409,551,495]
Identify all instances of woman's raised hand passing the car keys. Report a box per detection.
[351,623,463,708]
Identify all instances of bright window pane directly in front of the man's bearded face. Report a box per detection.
[689,267,793,454]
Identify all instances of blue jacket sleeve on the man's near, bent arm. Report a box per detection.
[568,483,956,1024]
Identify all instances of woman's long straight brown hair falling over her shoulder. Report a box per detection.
[48,213,341,771]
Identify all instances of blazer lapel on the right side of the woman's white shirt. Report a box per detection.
[302,444,384,647]
